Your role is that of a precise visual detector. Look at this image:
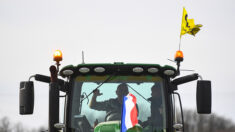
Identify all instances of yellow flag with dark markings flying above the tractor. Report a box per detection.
[180,8,202,37]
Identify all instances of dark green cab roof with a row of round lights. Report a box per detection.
[59,62,176,77]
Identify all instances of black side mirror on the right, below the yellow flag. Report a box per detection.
[197,80,212,114]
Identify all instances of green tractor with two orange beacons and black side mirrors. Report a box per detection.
[19,52,211,132]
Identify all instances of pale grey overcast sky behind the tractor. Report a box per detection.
[0,0,235,130]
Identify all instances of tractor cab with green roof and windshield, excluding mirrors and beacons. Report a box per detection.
[60,63,176,132]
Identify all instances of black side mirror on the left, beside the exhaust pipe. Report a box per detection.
[19,81,34,115]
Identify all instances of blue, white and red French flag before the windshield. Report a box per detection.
[121,93,138,132]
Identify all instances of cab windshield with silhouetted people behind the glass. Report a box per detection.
[70,75,166,132]
